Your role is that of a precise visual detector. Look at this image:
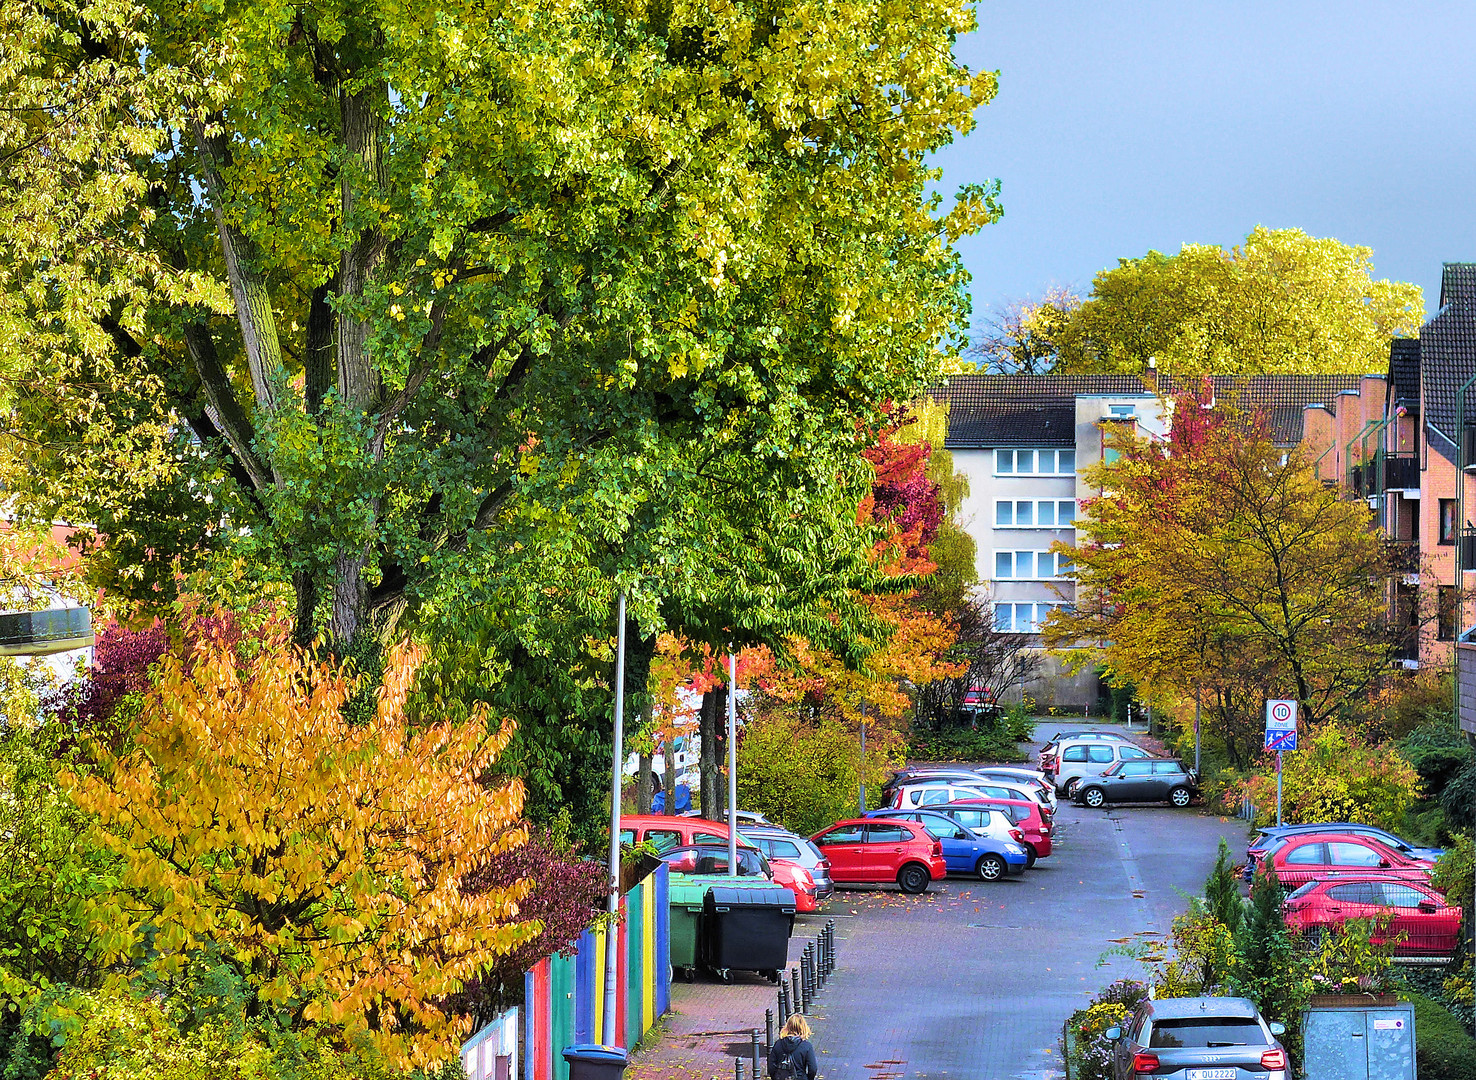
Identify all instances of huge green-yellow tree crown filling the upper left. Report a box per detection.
[0,0,998,649]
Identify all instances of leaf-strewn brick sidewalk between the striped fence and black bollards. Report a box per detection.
[626,901,850,1080]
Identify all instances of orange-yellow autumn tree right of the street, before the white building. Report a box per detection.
[1045,395,1399,766]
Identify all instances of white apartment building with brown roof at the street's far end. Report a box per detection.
[933,373,1381,707]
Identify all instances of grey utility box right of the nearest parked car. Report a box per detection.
[1302,1002,1416,1080]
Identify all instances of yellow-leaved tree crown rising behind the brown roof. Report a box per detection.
[1027,226,1424,375]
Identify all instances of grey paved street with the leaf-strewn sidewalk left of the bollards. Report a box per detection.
[630,728,1246,1080]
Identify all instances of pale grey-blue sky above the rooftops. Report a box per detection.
[936,0,1476,328]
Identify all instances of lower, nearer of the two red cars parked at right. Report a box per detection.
[1284,875,1461,956]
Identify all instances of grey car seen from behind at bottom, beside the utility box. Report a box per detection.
[1107,997,1290,1080]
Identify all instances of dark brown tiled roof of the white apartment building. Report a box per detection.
[933,375,1364,449]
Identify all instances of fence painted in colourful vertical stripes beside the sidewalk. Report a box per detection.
[523,865,672,1080]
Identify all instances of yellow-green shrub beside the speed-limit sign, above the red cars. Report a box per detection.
[1246,721,1420,829]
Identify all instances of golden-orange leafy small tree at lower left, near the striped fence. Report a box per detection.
[65,639,537,1068]
